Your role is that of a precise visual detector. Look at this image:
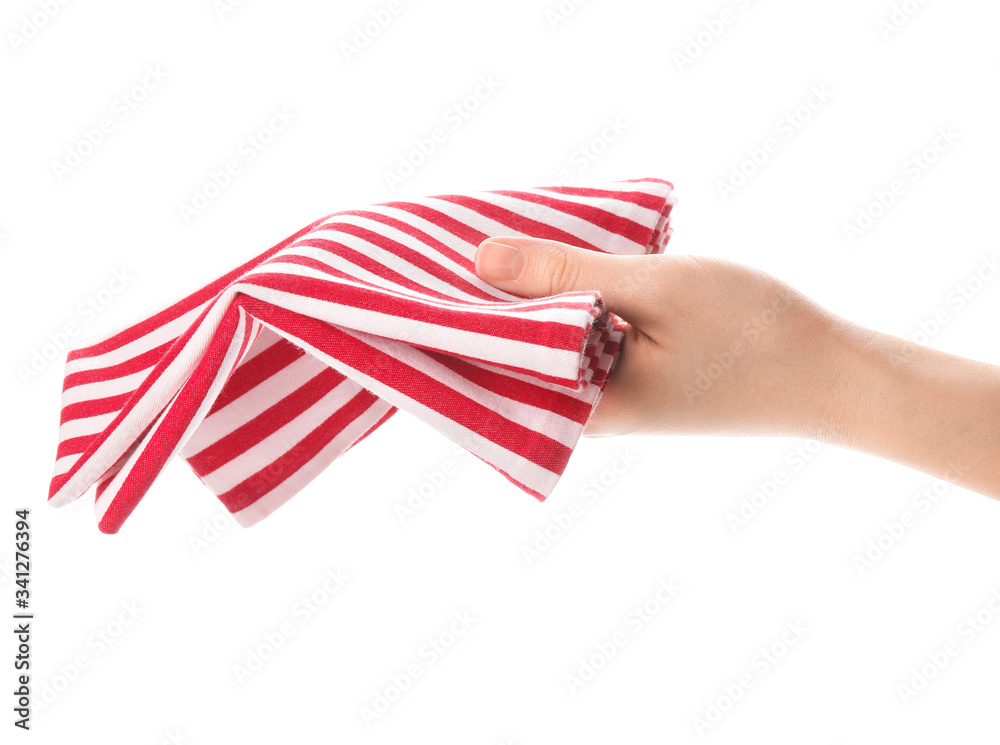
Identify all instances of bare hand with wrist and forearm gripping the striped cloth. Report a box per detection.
[476,236,1000,498]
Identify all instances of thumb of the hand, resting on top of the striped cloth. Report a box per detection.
[475,236,656,323]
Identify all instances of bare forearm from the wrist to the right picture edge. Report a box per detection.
[827,319,1000,498]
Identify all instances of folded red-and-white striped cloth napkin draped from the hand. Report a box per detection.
[49,178,675,533]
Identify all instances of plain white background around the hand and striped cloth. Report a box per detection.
[0,0,1000,745]
